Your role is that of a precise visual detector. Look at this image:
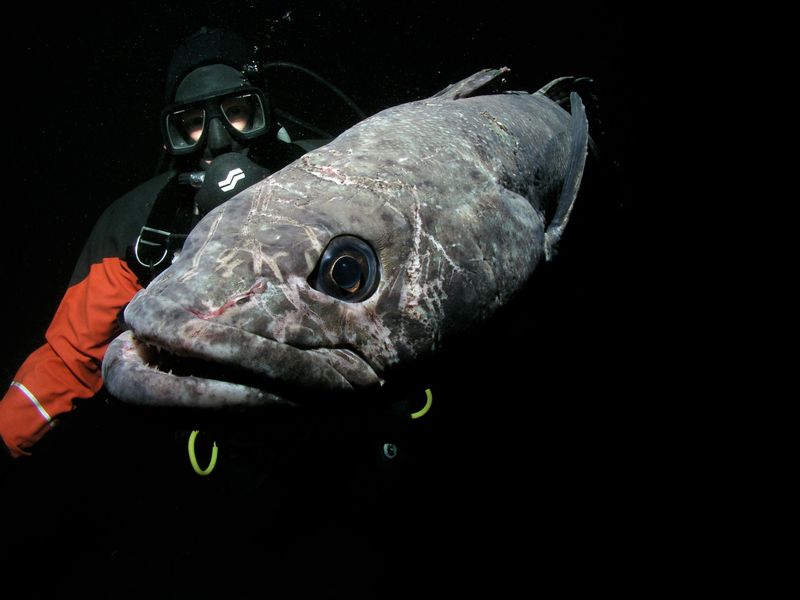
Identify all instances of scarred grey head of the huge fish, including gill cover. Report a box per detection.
[103,137,542,406]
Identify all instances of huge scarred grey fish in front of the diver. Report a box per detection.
[103,69,588,407]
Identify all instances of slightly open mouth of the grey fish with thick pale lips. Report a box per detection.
[102,326,383,408]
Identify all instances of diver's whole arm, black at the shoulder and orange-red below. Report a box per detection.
[0,172,166,457]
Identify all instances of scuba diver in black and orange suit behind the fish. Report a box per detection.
[0,27,326,458]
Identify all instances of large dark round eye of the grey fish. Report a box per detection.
[308,235,380,302]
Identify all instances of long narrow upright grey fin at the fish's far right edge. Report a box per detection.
[544,92,589,260]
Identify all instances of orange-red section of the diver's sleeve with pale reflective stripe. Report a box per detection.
[0,257,141,457]
